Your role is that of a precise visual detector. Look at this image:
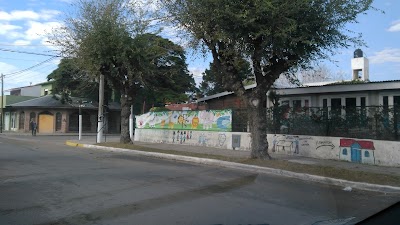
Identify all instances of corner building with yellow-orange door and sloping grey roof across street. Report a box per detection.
[4,95,121,133]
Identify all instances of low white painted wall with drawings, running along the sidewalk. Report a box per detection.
[134,129,400,166]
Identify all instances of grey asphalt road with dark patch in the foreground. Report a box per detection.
[0,136,400,225]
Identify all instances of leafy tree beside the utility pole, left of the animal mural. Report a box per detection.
[50,0,194,143]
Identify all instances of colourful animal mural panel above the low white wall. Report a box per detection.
[136,109,232,131]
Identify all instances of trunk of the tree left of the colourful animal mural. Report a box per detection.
[120,94,133,144]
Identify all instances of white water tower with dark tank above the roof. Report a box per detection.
[351,49,369,81]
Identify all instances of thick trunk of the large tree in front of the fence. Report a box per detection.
[246,87,271,159]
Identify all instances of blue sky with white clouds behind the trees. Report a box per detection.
[0,0,400,94]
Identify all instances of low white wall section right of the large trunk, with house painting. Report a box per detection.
[268,135,400,166]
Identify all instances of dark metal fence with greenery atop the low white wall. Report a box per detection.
[232,106,400,140]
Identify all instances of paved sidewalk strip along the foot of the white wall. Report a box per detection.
[71,138,400,177]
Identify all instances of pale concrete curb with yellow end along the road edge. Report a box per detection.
[65,141,400,193]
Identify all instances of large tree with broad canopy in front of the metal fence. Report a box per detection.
[162,0,372,158]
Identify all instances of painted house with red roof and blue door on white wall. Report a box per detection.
[339,138,375,164]
